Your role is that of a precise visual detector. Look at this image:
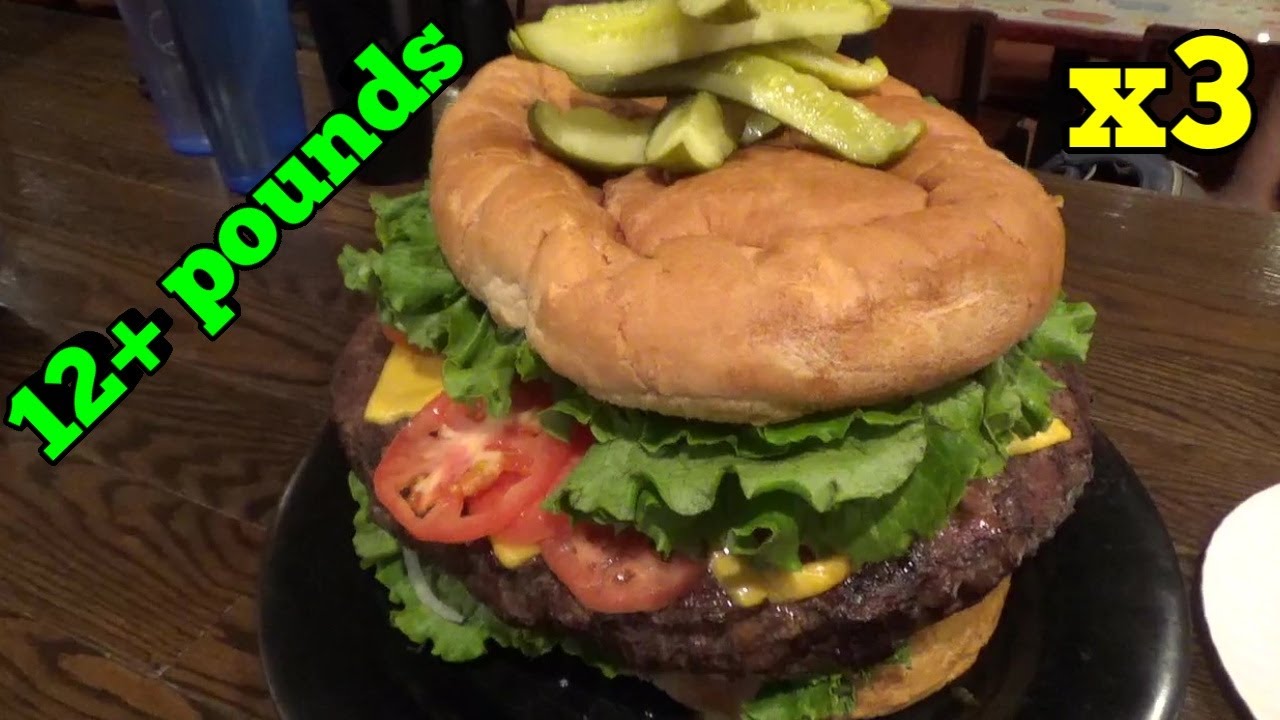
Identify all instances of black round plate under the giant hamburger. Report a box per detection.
[260,428,1189,720]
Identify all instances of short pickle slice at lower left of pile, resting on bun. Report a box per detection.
[529,100,655,173]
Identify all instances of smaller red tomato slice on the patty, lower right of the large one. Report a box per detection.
[543,524,707,612]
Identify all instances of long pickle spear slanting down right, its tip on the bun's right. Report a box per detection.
[573,50,924,165]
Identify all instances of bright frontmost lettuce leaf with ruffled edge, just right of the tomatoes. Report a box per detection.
[548,420,927,569]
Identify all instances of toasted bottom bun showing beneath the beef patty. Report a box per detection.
[649,578,1009,720]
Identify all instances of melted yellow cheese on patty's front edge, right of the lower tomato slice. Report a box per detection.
[712,552,854,607]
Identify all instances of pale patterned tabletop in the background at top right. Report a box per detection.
[890,0,1280,42]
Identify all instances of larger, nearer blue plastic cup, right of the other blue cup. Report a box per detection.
[168,0,307,195]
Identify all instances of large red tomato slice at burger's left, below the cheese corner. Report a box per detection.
[374,393,579,543]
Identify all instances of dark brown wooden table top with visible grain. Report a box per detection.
[0,1,1280,720]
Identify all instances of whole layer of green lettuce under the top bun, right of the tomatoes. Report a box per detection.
[543,299,1093,569]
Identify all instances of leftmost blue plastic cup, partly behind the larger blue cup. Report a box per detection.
[115,0,210,155]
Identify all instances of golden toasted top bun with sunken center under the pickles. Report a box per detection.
[431,58,1065,423]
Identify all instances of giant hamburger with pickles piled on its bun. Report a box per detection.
[334,0,1093,720]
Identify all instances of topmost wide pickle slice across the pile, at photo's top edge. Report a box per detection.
[516,0,884,76]
